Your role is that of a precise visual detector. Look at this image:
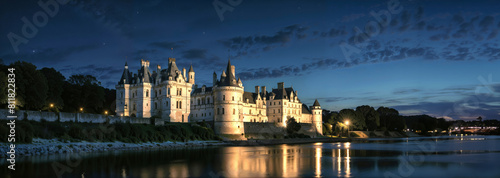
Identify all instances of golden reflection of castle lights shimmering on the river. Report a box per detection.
[215,143,351,177]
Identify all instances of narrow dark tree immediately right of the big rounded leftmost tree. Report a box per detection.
[40,68,66,111]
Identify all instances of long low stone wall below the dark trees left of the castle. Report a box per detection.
[0,109,151,125]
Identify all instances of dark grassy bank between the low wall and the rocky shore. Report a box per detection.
[0,120,220,143]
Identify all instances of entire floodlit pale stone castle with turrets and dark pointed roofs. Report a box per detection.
[116,58,323,135]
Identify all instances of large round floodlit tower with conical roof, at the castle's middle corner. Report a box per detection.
[213,60,245,135]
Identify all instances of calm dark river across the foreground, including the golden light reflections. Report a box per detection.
[0,136,500,177]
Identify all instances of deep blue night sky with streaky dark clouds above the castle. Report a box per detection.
[0,0,500,120]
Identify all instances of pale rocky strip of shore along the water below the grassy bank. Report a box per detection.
[0,138,230,157]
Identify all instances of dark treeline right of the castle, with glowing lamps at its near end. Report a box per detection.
[323,105,499,135]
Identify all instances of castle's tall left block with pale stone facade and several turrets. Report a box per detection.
[116,58,195,122]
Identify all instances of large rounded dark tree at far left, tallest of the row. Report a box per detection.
[9,61,49,110]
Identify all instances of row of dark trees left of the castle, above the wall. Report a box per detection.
[0,61,116,114]
